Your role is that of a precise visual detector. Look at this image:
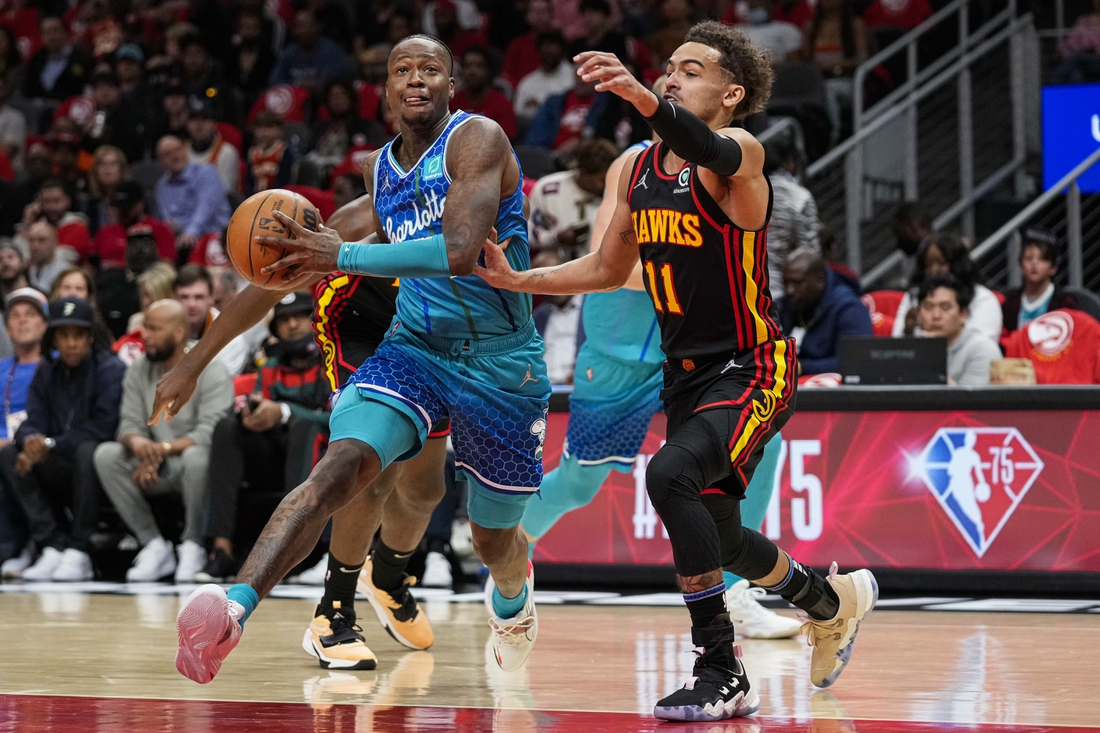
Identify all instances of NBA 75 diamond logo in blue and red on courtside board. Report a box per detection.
[920,428,1043,557]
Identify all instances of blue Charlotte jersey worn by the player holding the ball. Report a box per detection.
[374,111,531,339]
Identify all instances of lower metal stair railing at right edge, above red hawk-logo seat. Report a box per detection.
[970,149,1100,287]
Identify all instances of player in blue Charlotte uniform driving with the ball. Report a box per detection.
[176,35,550,682]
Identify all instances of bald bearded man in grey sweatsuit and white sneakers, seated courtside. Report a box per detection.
[95,300,233,582]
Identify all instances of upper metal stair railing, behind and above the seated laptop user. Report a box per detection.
[805,0,1034,286]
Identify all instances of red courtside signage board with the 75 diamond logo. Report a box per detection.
[532,411,1100,571]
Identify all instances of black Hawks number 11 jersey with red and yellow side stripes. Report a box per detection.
[627,143,782,363]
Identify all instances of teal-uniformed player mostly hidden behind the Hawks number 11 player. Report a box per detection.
[523,134,802,638]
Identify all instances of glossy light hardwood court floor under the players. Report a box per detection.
[0,593,1100,733]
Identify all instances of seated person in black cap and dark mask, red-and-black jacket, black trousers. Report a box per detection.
[198,293,329,582]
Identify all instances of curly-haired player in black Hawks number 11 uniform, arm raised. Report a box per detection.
[479,22,878,720]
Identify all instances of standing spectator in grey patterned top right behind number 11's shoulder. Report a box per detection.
[763,128,822,300]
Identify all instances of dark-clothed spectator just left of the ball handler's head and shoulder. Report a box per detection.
[305,79,388,185]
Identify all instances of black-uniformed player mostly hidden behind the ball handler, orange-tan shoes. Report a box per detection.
[152,195,449,669]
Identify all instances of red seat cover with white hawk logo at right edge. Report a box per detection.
[1001,310,1100,384]
